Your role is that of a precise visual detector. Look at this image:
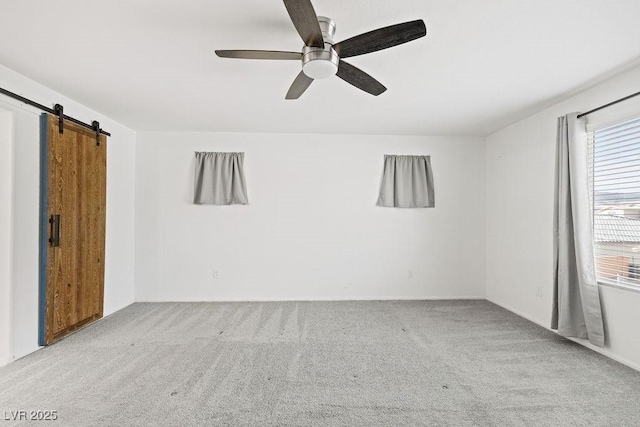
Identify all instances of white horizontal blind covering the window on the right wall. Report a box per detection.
[587,117,640,288]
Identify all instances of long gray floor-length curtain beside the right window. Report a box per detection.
[551,113,604,347]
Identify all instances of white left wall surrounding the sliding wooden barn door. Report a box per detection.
[0,66,136,359]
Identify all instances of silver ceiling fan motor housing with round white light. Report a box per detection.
[302,16,340,79]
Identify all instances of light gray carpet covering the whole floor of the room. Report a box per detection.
[0,301,640,426]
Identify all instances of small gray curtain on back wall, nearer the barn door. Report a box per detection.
[193,152,249,205]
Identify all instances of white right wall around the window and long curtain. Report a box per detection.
[486,68,640,369]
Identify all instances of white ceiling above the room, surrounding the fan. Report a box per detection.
[0,0,640,136]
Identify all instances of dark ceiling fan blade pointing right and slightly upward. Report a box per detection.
[333,19,427,58]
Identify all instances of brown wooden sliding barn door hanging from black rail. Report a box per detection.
[40,114,107,345]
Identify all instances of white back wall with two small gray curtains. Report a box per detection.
[136,133,485,301]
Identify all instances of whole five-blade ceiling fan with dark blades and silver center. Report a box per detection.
[216,0,427,99]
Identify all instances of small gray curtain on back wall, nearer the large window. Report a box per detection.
[377,155,436,208]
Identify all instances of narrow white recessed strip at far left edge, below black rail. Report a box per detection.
[0,109,13,366]
